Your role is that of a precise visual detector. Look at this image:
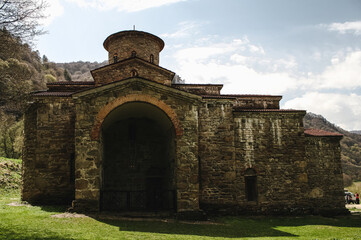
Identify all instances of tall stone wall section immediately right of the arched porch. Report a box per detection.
[199,99,237,209]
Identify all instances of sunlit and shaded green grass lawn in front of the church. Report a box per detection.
[0,191,361,240]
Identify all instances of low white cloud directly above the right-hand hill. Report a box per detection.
[283,92,361,130]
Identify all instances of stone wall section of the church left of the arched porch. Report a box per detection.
[22,97,75,204]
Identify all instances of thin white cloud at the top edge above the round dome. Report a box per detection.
[67,0,187,12]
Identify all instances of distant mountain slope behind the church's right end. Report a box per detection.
[304,113,361,181]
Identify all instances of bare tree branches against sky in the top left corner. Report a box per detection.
[0,0,48,41]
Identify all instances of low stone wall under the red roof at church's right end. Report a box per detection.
[306,136,345,213]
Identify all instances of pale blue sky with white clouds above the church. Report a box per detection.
[36,0,361,130]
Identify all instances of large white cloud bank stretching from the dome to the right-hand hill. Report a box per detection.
[169,33,361,130]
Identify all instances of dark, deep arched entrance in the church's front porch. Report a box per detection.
[101,102,176,211]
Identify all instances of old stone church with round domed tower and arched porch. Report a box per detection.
[22,30,345,216]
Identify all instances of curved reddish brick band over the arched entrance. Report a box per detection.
[91,94,183,140]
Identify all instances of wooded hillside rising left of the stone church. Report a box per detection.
[0,29,66,158]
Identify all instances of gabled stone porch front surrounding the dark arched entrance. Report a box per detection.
[74,79,199,211]
